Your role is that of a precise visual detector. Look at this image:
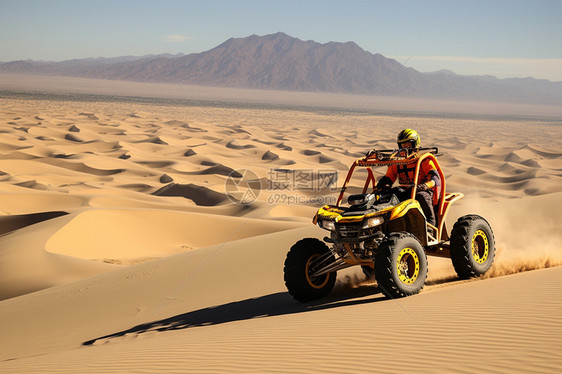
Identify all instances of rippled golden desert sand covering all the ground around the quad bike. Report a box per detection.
[0,90,562,373]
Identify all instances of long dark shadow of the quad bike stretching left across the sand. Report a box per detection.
[82,285,385,345]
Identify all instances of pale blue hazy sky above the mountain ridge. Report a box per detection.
[0,0,562,81]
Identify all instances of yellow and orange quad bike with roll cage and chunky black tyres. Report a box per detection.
[284,148,495,302]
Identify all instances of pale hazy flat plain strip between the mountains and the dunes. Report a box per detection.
[4,73,562,121]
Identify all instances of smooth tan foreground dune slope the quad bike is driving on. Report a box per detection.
[1,229,562,372]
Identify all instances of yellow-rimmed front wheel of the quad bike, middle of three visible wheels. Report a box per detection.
[375,232,427,299]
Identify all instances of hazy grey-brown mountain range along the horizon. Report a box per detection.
[0,32,562,105]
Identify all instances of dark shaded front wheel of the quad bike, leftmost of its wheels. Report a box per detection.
[283,238,336,303]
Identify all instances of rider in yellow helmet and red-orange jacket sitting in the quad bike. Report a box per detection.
[377,129,441,226]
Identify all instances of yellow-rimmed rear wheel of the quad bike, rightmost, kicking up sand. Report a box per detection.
[451,215,496,279]
